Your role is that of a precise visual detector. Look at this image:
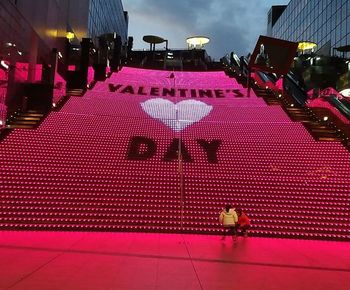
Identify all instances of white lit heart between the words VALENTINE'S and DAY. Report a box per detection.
[141,98,213,132]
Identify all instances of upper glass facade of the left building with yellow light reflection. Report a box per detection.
[0,0,128,61]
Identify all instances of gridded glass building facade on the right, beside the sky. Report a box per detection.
[268,0,350,57]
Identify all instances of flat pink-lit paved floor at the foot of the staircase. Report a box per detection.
[0,231,350,290]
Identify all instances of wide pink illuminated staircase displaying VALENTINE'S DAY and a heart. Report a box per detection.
[0,67,350,240]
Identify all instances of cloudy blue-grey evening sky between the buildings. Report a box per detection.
[122,0,289,60]
